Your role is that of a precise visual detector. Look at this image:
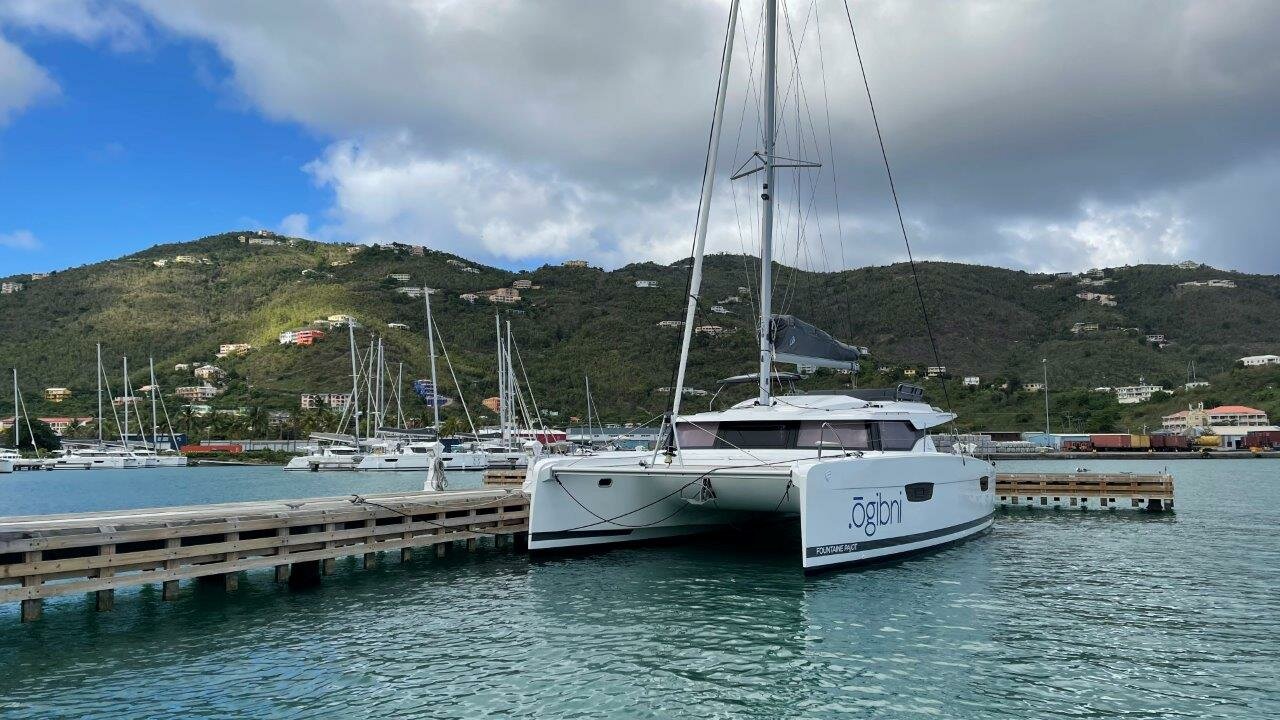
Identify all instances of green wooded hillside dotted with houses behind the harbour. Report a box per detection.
[0,232,1280,432]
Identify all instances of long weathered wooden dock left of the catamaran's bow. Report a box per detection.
[0,488,529,621]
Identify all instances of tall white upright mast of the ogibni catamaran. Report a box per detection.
[758,0,778,405]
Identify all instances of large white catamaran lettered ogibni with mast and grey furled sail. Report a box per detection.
[525,0,995,571]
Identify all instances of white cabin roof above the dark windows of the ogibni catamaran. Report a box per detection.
[676,391,955,429]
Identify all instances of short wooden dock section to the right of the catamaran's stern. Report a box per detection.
[996,473,1174,511]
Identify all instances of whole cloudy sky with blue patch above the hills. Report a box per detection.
[0,0,1280,275]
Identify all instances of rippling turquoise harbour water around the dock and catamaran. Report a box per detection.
[0,460,1280,719]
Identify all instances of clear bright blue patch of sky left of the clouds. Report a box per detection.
[0,30,326,274]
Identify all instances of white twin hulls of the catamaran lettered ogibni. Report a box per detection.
[526,454,995,571]
